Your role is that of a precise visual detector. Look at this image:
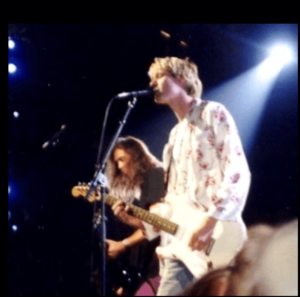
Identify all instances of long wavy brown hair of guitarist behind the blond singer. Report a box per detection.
[106,136,162,189]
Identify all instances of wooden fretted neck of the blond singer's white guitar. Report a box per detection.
[105,195,178,235]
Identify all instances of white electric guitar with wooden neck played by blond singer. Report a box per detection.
[71,185,247,278]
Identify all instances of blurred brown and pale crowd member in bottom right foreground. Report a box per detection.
[180,219,298,296]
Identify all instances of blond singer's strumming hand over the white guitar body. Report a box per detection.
[189,217,218,251]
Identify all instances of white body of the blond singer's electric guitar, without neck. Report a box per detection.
[156,196,247,278]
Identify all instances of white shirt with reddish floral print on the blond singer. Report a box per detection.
[163,98,251,221]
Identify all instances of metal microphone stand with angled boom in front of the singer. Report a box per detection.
[84,97,137,296]
